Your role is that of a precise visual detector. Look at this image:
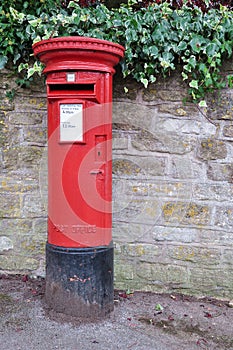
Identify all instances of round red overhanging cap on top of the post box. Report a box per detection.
[33,36,124,73]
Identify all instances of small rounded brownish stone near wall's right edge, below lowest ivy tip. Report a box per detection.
[198,138,227,160]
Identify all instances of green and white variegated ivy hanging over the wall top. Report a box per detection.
[0,0,233,101]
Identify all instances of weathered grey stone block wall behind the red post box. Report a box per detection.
[0,62,233,298]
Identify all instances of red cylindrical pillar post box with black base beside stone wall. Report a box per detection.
[33,37,124,317]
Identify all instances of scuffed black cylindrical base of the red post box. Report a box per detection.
[45,243,114,319]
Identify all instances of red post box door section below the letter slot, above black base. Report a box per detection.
[48,99,112,247]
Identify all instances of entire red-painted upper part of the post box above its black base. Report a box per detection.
[33,37,124,248]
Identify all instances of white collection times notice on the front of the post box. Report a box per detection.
[60,103,83,142]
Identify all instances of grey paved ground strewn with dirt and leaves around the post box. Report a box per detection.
[0,275,233,350]
